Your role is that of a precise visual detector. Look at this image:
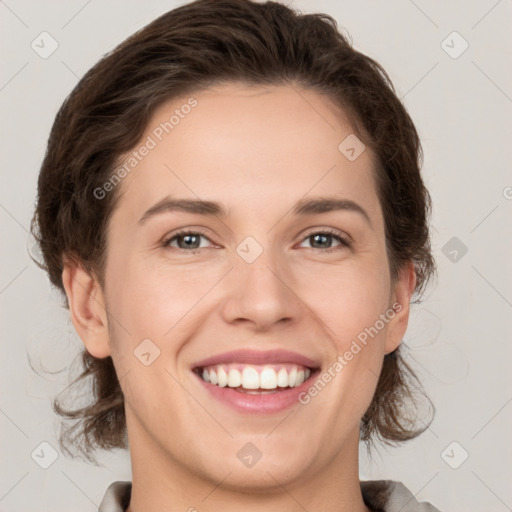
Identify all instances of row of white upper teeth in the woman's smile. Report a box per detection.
[202,365,311,389]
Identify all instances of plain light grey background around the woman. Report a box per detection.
[0,0,512,512]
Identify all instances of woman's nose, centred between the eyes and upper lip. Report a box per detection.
[222,250,304,331]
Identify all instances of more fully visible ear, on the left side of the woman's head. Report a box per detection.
[62,261,111,359]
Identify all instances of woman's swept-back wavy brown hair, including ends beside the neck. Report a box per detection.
[31,0,436,461]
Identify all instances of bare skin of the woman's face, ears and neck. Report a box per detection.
[63,84,416,512]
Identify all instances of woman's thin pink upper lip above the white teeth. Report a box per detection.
[193,349,320,368]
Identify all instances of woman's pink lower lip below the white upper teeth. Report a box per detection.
[194,370,318,414]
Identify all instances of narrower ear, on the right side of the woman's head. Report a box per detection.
[385,261,416,354]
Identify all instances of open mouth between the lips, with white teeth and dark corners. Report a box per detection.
[194,363,318,394]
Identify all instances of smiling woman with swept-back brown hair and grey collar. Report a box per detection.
[33,0,437,512]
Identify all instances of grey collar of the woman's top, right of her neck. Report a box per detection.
[360,480,441,512]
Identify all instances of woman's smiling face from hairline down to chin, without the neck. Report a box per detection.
[67,84,414,487]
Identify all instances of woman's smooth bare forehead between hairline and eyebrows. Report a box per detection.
[112,84,379,227]
